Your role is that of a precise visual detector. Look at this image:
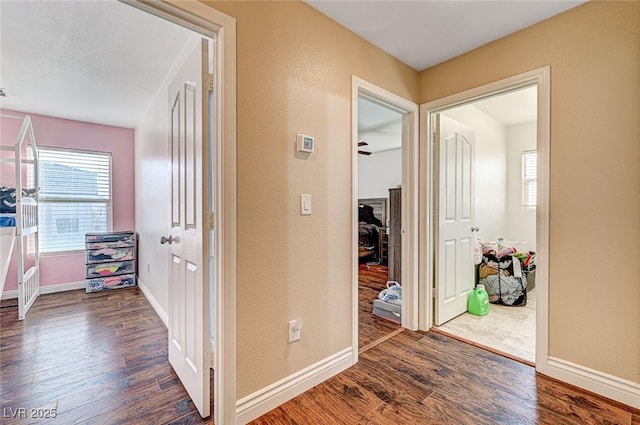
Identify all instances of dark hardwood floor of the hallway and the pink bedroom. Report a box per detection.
[0,288,640,425]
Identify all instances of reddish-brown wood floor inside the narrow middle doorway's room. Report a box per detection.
[358,264,401,351]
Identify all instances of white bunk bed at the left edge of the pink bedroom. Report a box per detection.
[0,115,40,320]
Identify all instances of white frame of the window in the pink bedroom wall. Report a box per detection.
[37,146,113,256]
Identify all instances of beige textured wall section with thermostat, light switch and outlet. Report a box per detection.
[202,2,418,398]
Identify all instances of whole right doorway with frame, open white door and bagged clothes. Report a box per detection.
[421,68,550,370]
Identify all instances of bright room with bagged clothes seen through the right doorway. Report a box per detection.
[434,86,537,363]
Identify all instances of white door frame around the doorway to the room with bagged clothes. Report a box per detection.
[419,66,551,373]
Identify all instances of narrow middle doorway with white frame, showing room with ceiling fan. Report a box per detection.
[351,77,418,362]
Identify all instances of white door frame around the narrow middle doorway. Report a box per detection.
[351,76,418,364]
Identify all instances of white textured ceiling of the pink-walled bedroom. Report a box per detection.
[0,0,195,128]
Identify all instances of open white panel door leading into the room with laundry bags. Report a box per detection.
[434,114,475,325]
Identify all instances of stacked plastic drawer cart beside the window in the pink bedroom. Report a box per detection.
[85,232,137,293]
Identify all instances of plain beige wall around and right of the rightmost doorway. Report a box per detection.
[420,2,640,383]
